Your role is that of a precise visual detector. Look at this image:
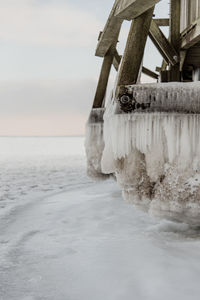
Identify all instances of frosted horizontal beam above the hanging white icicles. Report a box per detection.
[128,82,200,113]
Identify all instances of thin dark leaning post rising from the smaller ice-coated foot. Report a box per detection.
[93,45,115,108]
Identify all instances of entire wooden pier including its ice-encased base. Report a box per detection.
[86,0,200,220]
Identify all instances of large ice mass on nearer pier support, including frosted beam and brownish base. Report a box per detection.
[101,83,200,223]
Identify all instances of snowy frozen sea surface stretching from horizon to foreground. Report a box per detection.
[0,137,200,300]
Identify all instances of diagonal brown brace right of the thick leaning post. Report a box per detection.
[149,20,178,65]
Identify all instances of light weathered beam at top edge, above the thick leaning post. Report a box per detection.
[115,0,160,20]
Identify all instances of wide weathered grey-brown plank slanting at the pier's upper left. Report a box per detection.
[95,0,123,57]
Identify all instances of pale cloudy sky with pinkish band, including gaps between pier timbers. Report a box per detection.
[0,0,168,136]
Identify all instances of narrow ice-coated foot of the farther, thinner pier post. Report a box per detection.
[85,108,107,178]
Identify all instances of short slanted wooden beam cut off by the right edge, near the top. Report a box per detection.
[181,18,200,50]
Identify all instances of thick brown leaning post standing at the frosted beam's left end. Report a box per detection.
[116,6,154,95]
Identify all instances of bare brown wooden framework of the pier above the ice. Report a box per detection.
[93,0,200,108]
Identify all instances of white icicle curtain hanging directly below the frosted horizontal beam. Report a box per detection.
[104,113,200,169]
